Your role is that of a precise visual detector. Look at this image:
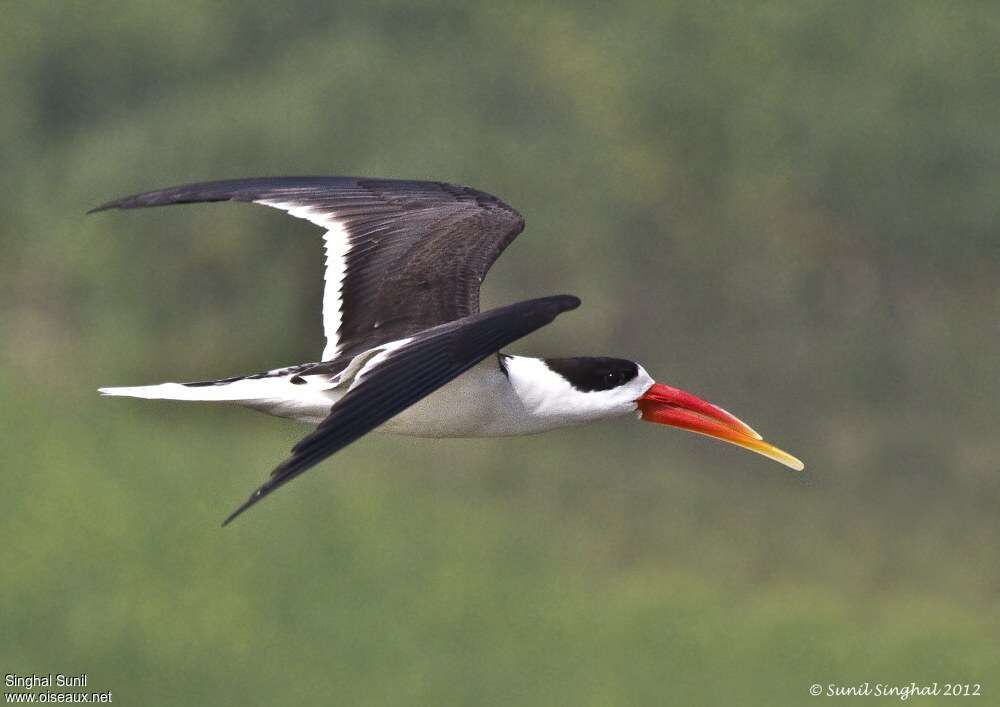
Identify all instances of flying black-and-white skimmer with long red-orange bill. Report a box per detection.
[88,177,804,526]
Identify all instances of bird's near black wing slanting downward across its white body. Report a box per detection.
[223,295,580,525]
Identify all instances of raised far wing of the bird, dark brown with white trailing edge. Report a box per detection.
[91,177,524,360]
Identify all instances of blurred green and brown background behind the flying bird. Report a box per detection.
[0,0,1000,706]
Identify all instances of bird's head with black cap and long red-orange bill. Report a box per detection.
[544,357,804,471]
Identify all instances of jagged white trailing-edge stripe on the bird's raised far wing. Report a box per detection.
[254,199,351,361]
